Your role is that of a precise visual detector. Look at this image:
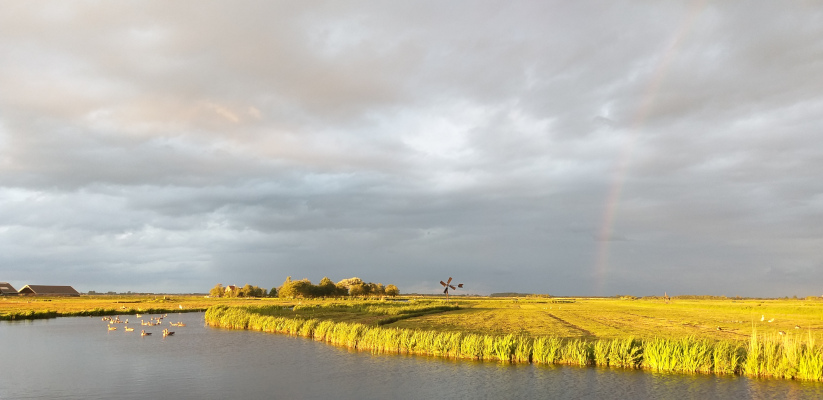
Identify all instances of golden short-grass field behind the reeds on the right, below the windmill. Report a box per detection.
[392,299,823,341]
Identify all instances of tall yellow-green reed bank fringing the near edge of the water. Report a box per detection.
[206,304,823,381]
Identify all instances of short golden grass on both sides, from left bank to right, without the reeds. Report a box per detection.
[0,295,823,341]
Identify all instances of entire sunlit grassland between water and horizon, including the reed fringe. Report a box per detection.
[0,295,823,381]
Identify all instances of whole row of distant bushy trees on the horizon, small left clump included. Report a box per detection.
[209,276,400,299]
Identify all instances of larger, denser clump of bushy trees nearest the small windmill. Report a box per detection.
[277,276,400,298]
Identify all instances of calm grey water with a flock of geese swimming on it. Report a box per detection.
[0,313,823,399]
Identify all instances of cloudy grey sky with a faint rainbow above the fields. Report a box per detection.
[0,0,823,297]
